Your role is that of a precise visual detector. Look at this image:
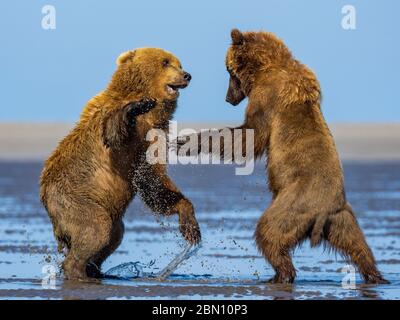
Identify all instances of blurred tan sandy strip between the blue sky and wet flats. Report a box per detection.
[0,123,400,161]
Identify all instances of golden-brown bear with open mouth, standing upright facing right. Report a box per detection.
[40,48,200,279]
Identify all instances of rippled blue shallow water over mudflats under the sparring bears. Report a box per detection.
[0,162,400,299]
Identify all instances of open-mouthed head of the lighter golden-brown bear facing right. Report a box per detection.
[109,48,191,101]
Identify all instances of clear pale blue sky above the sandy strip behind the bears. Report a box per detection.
[0,0,400,122]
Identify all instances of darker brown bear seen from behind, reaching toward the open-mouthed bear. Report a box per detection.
[184,29,387,283]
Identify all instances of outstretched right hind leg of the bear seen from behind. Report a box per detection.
[326,204,389,283]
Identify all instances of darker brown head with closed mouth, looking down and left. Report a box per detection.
[226,29,294,106]
